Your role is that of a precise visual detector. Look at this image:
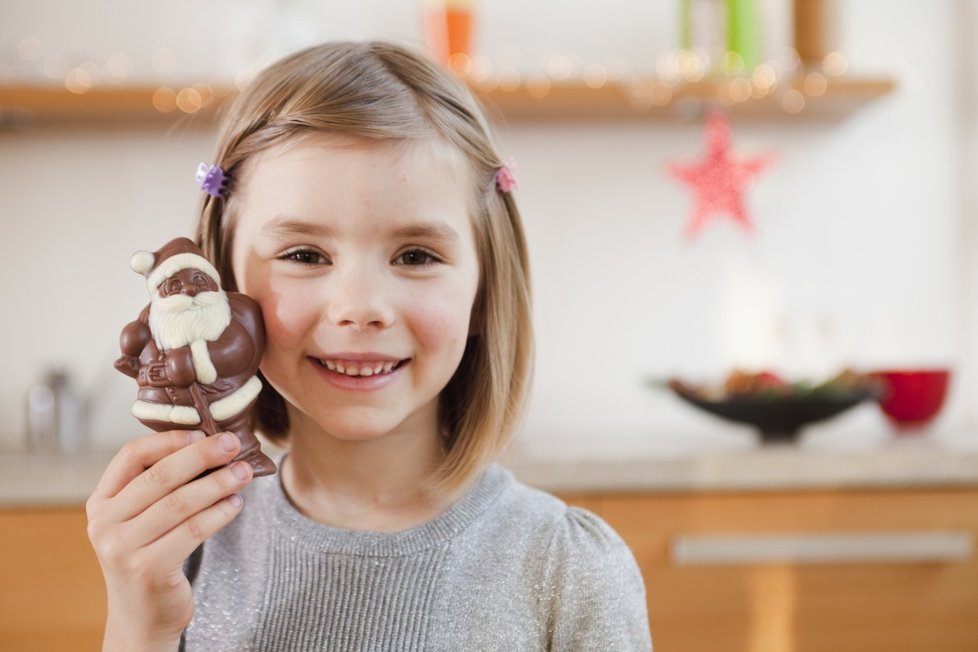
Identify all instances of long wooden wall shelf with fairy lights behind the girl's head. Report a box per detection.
[0,77,896,127]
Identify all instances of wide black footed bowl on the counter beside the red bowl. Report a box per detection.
[672,387,877,443]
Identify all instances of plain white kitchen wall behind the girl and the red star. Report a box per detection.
[0,0,964,451]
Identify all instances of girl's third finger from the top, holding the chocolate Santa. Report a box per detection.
[124,461,253,554]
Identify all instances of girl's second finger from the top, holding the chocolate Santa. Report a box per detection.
[113,432,241,521]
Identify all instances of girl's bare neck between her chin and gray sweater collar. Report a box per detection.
[282,418,453,532]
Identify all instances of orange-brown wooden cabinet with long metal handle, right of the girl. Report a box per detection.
[565,488,978,652]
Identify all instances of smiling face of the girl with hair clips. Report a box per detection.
[231,134,479,440]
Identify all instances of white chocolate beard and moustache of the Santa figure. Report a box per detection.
[149,290,231,351]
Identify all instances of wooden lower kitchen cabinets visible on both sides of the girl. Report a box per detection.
[7,487,978,652]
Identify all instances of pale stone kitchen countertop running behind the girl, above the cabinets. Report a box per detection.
[0,433,978,507]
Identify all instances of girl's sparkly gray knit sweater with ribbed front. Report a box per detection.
[182,466,652,652]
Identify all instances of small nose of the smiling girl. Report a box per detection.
[324,272,394,329]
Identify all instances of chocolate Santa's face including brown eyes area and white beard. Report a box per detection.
[149,269,231,351]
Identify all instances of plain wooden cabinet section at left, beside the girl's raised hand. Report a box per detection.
[0,507,105,652]
